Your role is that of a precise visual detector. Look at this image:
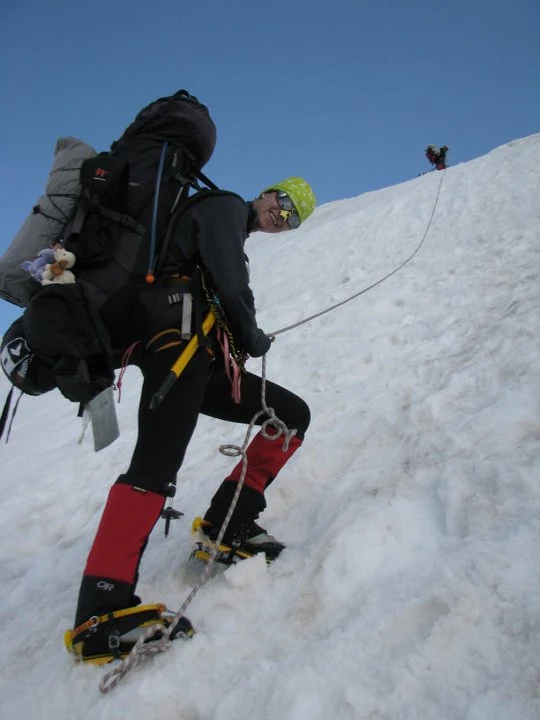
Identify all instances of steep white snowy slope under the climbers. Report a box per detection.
[0,135,540,720]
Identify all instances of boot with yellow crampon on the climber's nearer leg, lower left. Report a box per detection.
[64,603,194,665]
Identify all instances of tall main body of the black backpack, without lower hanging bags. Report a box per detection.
[64,90,216,306]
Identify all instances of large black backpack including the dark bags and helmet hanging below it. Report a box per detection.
[0,90,216,410]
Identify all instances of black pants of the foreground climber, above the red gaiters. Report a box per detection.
[103,288,310,493]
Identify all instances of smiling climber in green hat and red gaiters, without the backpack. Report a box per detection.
[65,178,315,663]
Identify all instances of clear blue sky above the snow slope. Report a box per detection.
[0,0,540,332]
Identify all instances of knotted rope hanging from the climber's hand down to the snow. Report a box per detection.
[99,355,296,694]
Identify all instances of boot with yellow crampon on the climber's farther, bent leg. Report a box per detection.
[191,517,286,565]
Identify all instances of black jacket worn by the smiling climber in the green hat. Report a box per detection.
[162,190,270,357]
